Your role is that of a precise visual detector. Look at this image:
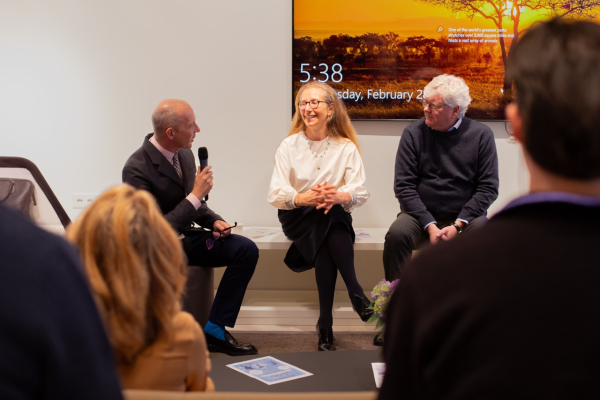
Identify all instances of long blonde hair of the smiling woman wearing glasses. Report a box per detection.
[288,81,360,151]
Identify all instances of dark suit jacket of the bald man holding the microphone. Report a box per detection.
[123,133,223,233]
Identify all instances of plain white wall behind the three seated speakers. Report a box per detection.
[0,0,526,227]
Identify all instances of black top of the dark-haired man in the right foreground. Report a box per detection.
[380,202,600,400]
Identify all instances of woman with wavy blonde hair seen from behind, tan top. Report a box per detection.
[67,185,214,391]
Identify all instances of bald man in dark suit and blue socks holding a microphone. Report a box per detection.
[123,99,258,355]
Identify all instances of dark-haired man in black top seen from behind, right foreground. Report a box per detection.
[379,19,600,400]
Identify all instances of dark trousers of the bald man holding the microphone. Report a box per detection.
[183,231,258,328]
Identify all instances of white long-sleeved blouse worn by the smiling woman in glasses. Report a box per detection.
[267,132,369,212]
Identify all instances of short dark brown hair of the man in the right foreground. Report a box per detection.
[506,18,600,180]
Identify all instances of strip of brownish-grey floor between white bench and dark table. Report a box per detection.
[210,332,380,358]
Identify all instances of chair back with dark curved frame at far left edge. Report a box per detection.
[0,157,71,235]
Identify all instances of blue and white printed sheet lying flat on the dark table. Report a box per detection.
[227,356,312,385]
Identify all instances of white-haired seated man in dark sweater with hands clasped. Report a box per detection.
[383,75,498,281]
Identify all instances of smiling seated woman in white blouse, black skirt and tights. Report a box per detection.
[268,82,373,351]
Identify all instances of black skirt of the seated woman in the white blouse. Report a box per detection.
[278,205,354,272]
